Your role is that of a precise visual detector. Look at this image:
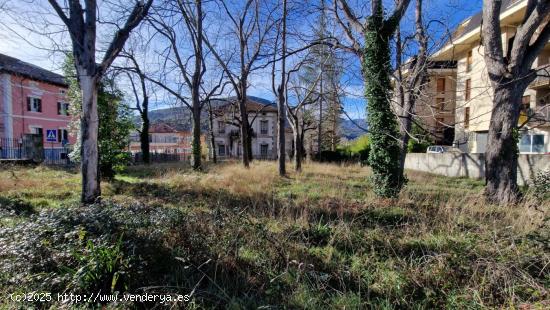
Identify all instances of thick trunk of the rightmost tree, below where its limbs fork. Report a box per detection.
[485,85,525,204]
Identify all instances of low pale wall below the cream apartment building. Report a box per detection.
[405,153,550,185]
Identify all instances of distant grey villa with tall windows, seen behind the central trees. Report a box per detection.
[208,97,294,159]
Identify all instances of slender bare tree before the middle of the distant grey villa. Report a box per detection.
[204,0,277,168]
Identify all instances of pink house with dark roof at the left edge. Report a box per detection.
[0,54,75,150]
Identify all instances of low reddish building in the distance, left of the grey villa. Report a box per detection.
[130,123,205,155]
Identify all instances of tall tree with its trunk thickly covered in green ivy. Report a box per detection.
[334,0,410,197]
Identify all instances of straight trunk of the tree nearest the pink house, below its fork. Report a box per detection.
[79,74,101,203]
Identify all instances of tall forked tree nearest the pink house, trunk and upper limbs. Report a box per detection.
[48,0,153,203]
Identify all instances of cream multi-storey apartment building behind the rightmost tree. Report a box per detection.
[431,0,550,153]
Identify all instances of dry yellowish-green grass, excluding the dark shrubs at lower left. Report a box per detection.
[0,161,550,309]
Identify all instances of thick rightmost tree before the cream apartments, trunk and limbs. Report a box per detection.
[482,0,550,204]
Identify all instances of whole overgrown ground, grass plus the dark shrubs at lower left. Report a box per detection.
[0,162,550,309]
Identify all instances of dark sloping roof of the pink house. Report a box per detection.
[0,54,67,87]
